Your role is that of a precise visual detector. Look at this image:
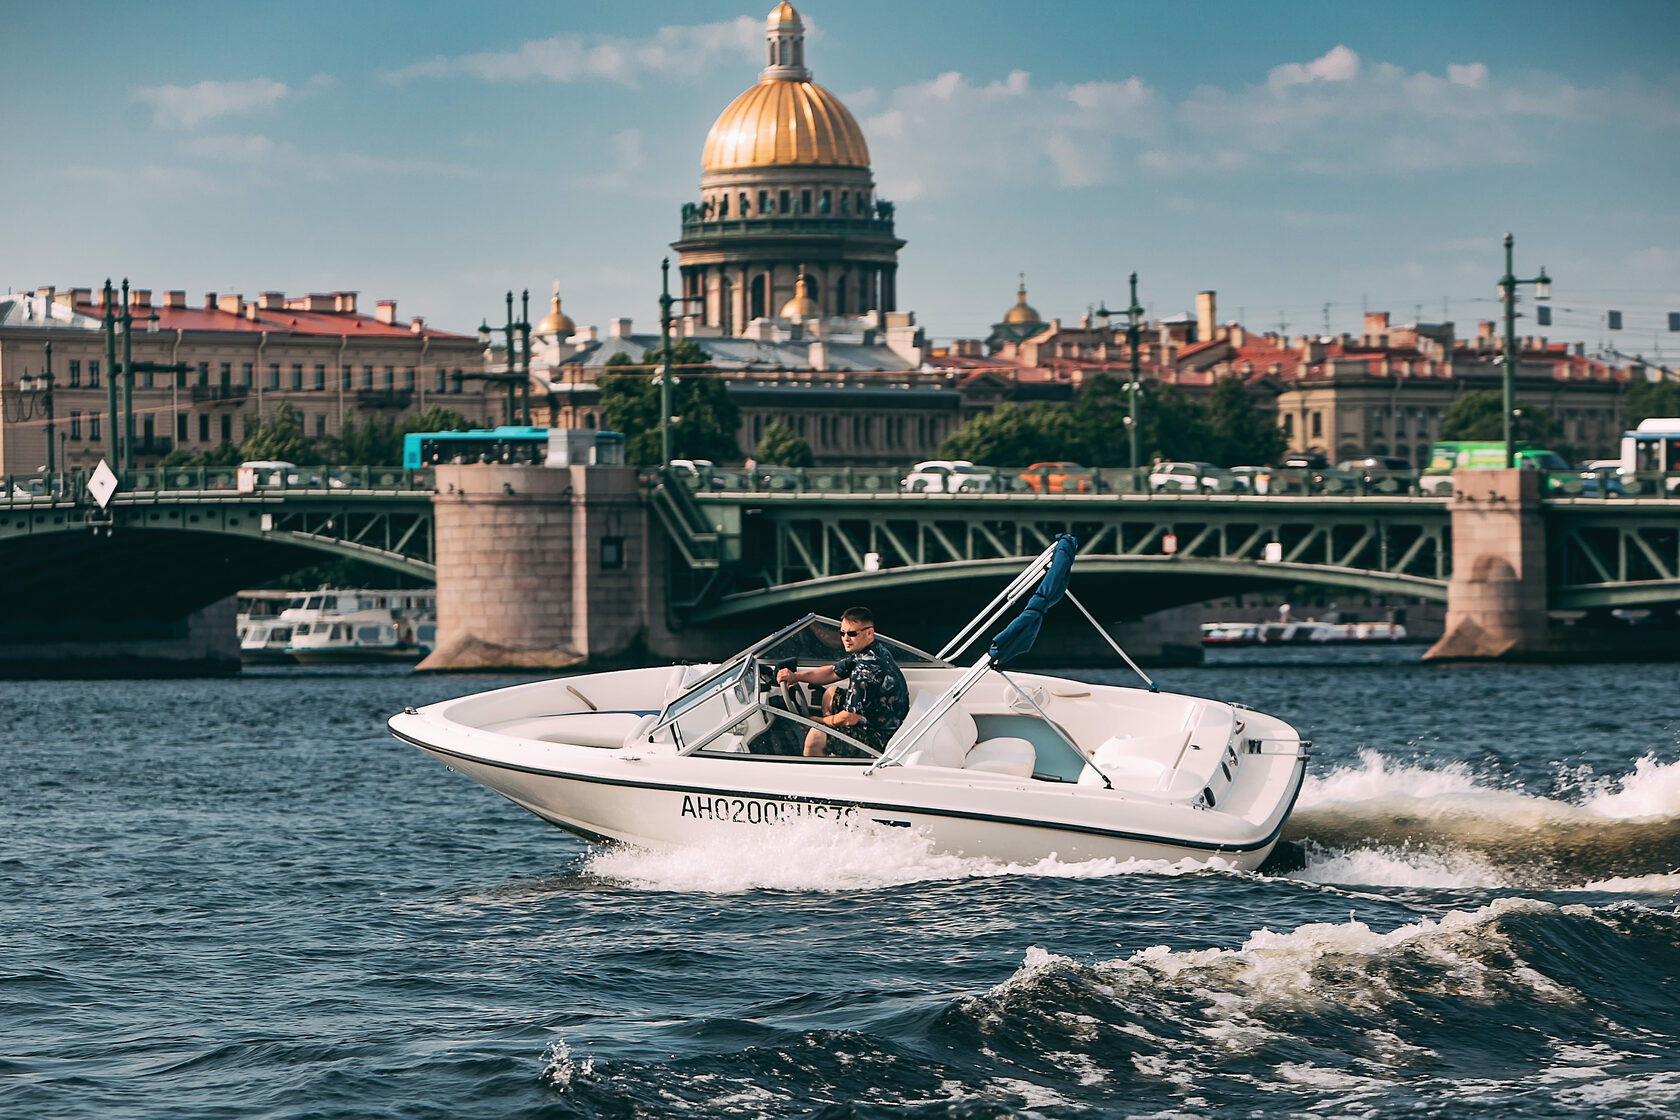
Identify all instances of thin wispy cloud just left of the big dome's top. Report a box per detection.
[380,15,764,86]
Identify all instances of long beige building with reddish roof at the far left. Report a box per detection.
[0,287,501,474]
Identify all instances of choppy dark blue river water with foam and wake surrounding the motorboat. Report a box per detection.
[0,648,1680,1120]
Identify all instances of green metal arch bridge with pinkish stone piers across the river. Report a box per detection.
[0,467,1680,671]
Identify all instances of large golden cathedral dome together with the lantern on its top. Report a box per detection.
[701,3,869,171]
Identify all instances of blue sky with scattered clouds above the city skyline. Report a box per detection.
[0,0,1680,366]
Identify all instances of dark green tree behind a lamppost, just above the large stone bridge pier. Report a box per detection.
[596,339,741,467]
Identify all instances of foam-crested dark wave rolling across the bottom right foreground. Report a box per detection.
[543,898,1680,1118]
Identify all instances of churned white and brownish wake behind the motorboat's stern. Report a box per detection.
[1285,751,1680,892]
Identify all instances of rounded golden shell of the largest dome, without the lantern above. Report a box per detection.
[701,78,869,171]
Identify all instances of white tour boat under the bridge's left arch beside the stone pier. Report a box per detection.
[281,591,437,665]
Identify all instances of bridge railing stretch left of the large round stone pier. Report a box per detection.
[0,467,437,505]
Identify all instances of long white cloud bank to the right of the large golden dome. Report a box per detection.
[864,45,1680,201]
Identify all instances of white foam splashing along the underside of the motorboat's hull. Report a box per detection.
[583,818,1230,893]
